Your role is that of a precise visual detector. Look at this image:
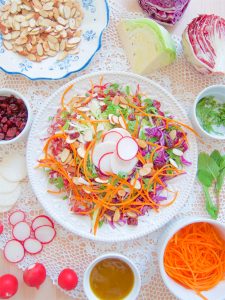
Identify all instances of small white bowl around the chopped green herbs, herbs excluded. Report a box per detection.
[191,85,225,140]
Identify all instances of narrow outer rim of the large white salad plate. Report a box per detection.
[26,71,197,243]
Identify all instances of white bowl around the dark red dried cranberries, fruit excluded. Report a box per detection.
[0,89,32,146]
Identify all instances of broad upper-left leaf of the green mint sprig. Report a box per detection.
[198,152,219,179]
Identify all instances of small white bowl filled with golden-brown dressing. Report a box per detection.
[83,253,141,300]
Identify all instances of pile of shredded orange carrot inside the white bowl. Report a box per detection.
[164,223,225,300]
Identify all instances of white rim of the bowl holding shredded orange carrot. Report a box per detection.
[158,216,225,300]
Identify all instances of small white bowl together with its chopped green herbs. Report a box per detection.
[192,85,225,140]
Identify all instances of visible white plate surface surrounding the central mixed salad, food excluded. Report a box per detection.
[27,72,198,242]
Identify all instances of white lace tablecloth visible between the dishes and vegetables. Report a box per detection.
[0,0,225,300]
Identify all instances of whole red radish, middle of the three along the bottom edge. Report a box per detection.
[23,263,46,289]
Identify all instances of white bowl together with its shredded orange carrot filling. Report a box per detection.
[159,217,225,300]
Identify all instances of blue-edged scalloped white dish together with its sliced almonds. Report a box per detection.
[0,0,109,80]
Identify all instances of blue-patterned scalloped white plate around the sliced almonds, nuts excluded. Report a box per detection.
[0,0,109,80]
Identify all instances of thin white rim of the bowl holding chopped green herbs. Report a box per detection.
[193,84,225,141]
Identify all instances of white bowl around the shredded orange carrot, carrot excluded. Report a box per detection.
[158,217,225,300]
